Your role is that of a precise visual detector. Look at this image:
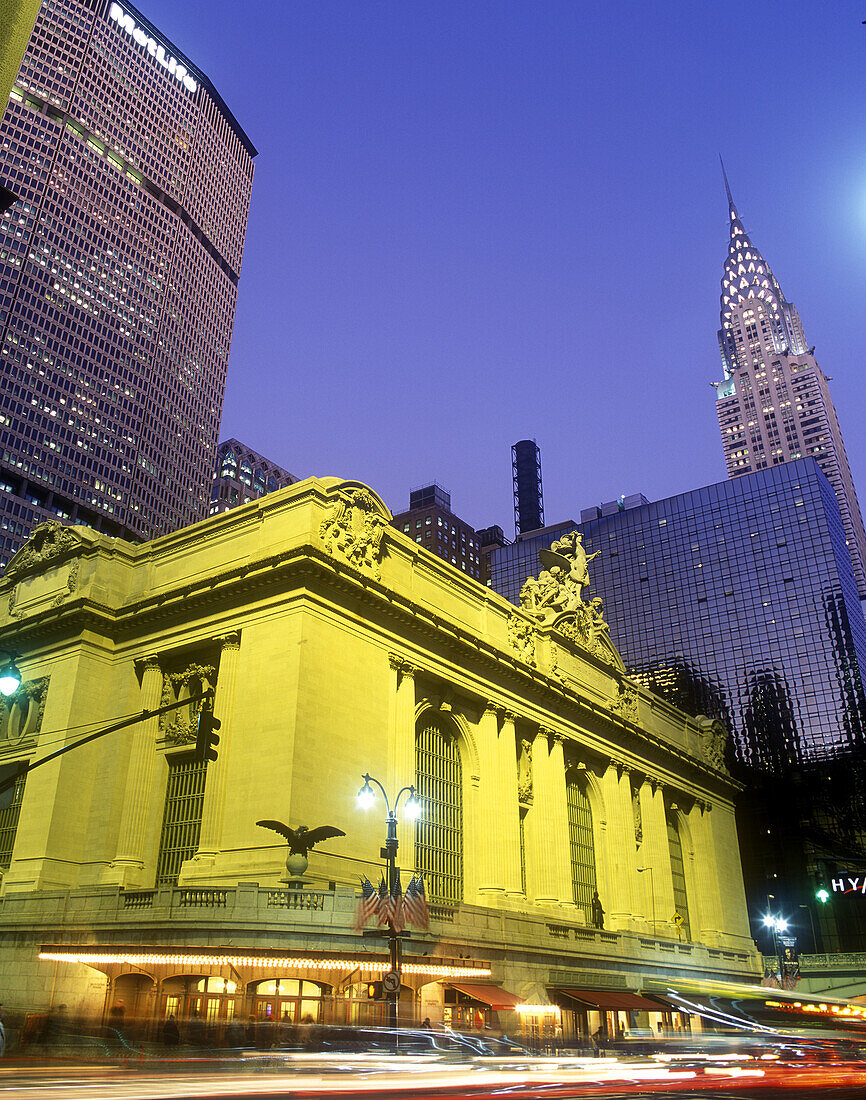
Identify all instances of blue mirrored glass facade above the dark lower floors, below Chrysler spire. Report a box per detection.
[491,459,866,771]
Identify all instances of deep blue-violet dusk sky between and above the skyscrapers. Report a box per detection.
[144,0,866,536]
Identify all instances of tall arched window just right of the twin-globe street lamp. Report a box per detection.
[415,715,463,905]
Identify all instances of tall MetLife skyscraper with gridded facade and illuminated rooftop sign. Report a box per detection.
[0,0,255,567]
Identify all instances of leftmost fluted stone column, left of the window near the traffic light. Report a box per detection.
[105,657,163,887]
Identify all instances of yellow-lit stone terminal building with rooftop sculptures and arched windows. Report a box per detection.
[0,479,760,1037]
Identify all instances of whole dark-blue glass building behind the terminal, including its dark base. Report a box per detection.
[491,459,866,954]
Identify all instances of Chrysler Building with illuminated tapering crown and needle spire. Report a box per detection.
[714,169,866,600]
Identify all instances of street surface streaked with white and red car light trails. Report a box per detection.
[0,1056,866,1100]
